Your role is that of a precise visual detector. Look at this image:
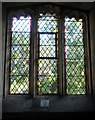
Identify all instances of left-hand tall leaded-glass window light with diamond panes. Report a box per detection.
[10,16,31,94]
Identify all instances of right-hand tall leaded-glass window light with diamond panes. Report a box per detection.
[64,17,86,94]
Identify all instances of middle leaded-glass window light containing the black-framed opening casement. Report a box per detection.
[37,14,58,94]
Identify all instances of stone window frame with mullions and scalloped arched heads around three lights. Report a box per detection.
[4,5,91,97]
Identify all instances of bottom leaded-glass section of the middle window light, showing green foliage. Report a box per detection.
[37,75,58,94]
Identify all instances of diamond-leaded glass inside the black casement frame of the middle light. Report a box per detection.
[39,34,56,57]
